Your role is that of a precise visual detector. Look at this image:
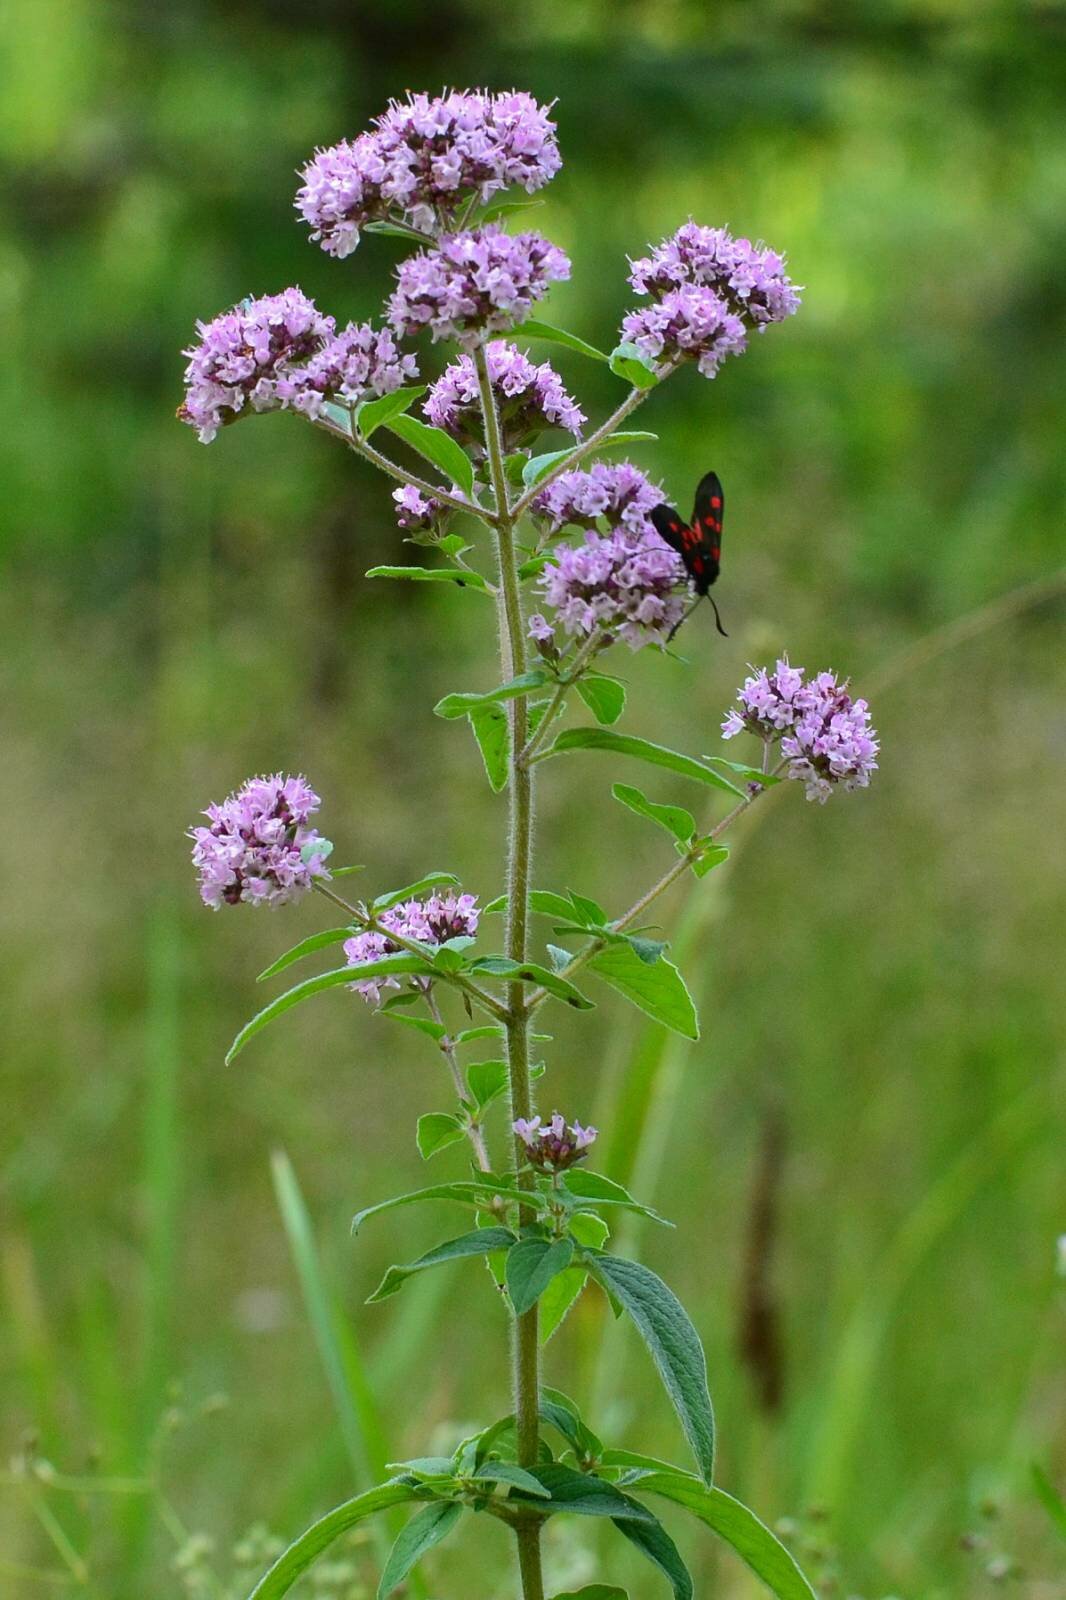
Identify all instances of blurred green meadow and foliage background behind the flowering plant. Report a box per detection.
[0,0,1066,1600]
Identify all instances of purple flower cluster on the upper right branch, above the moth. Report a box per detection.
[621,222,799,378]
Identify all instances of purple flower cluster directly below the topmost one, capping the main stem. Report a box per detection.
[382,224,570,347]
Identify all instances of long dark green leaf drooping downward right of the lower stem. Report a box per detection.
[589,1256,714,1483]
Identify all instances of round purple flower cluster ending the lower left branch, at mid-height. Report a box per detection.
[189,773,330,910]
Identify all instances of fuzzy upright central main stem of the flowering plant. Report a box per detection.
[474,347,544,1600]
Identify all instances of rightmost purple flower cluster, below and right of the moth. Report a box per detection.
[722,658,880,805]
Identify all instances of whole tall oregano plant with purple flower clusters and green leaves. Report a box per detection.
[179,84,877,1600]
